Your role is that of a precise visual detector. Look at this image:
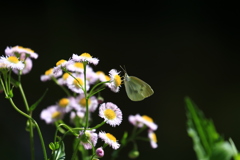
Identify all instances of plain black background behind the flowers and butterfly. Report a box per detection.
[0,0,240,160]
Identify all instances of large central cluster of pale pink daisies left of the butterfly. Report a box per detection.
[40,53,122,157]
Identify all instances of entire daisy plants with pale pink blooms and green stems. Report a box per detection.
[0,46,157,160]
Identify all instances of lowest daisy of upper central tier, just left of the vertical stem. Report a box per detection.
[67,74,90,94]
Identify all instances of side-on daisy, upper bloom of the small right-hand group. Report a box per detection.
[131,114,158,131]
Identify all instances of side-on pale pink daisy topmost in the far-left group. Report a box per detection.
[5,46,38,59]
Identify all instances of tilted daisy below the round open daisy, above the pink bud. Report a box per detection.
[98,131,120,150]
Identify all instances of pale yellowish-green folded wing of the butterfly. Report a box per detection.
[124,76,154,101]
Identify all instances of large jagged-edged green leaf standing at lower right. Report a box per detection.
[185,97,233,160]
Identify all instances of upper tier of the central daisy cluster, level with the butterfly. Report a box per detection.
[41,53,122,94]
